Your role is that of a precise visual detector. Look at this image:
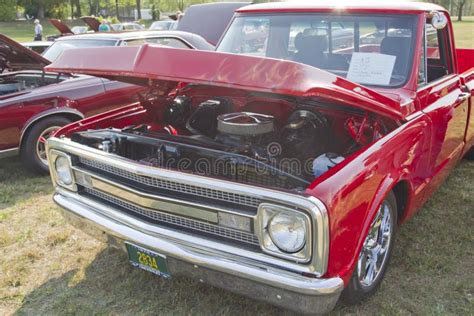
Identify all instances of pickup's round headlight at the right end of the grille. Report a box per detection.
[268,213,306,253]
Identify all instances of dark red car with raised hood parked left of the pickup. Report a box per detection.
[0,31,214,173]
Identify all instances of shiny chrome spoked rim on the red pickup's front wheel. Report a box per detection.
[357,201,394,288]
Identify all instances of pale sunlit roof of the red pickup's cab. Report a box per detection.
[236,0,446,13]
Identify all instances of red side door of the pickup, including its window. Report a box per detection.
[417,19,469,191]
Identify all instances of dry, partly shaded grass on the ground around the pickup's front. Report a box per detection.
[0,159,474,315]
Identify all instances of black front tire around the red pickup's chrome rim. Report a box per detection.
[341,192,398,305]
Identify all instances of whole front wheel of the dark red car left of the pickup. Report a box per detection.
[21,116,72,174]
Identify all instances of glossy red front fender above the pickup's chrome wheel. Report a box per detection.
[306,111,431,284]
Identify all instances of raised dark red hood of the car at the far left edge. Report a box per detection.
[0,34,50,73]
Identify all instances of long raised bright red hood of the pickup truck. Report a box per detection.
[46,44,403,120]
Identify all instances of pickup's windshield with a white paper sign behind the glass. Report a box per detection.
[217,14,416,87]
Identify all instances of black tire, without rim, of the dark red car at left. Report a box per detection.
[20,116,72,175]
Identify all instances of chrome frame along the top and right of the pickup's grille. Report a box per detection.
[47,137,329,276]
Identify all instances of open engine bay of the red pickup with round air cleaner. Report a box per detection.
[71,89,389,191]
